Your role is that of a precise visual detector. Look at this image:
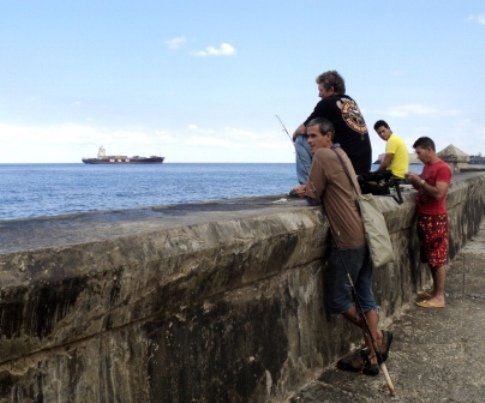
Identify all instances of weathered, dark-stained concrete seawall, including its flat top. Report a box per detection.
[0,174,485,402]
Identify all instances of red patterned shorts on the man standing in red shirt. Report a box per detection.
[418,214,448,269]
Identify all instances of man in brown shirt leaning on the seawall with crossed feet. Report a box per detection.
[294,118,392,375]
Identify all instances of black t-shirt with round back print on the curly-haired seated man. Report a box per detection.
[304,95,372,174]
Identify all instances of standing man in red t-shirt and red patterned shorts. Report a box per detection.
[406,137,451,308]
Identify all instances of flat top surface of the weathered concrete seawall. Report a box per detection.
[0,172,485,254]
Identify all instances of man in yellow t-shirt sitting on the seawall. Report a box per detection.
[374,120,409,179]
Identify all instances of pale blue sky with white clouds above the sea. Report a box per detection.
[0,0,485,163]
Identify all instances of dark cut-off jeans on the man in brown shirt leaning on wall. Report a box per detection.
[325,246,377,315]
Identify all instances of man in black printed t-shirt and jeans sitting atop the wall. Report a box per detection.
[293,70,372,184]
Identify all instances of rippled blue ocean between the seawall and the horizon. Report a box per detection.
[0,163,420,220]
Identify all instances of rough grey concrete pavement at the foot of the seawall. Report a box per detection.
[291,221,485,403]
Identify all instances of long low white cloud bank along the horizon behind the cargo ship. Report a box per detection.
[0,122,294,164]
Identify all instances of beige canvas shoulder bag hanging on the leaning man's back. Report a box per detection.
[334,150,394,267]
